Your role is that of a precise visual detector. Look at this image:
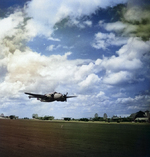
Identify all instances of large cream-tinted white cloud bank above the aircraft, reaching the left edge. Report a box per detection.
[0,27,96,98]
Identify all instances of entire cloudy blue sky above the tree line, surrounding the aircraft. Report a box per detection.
[0,0,150,118]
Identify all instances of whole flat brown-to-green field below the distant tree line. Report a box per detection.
[0,119,150,157]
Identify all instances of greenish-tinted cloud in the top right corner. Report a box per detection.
[103,0,150,41]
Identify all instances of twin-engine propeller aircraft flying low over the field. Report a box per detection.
[25,92,77,102]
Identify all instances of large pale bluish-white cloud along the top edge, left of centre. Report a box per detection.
[26,0,127,37]
